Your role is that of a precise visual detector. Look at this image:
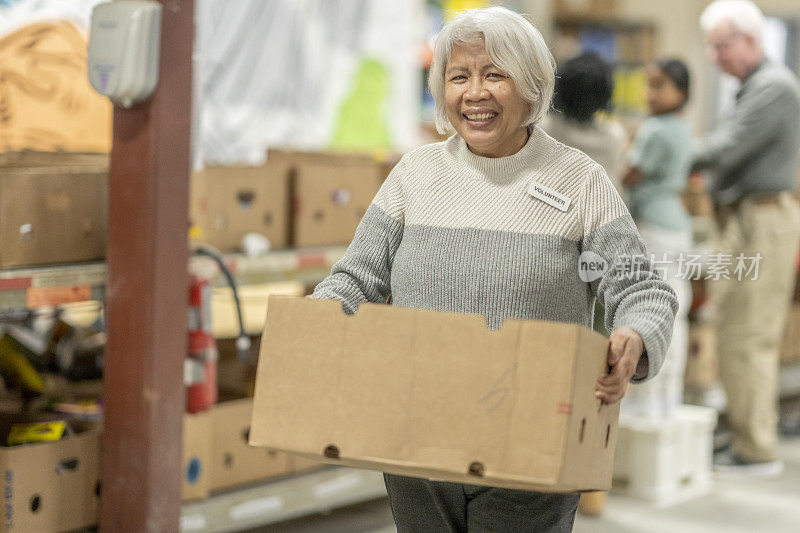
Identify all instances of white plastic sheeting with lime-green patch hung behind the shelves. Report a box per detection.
[0,0,425,166]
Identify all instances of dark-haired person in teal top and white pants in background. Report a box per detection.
[621,59,692,419]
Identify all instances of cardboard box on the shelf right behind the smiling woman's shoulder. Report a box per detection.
[284,154,387,247]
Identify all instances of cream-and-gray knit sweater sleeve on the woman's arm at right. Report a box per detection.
[581,166,678,383]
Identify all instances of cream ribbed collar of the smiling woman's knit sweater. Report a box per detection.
[446,126,554,183]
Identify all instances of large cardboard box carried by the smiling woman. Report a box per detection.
[250,296,619,492]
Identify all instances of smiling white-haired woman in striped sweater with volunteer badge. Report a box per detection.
[313,7,677,532]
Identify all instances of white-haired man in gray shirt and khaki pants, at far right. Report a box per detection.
[694,0,800,476]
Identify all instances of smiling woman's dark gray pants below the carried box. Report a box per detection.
[383,474,580,533]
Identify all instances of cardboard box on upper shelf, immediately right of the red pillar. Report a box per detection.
[190,160,289,252]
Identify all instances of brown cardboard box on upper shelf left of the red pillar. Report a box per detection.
[0,157,108,268]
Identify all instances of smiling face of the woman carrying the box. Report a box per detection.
[444,39,530,157]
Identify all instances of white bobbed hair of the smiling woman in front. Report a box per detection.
[428,7,555,133]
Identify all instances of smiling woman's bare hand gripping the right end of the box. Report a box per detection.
[595,327,644,404]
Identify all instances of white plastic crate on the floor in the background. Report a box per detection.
[612,405,717,507]
